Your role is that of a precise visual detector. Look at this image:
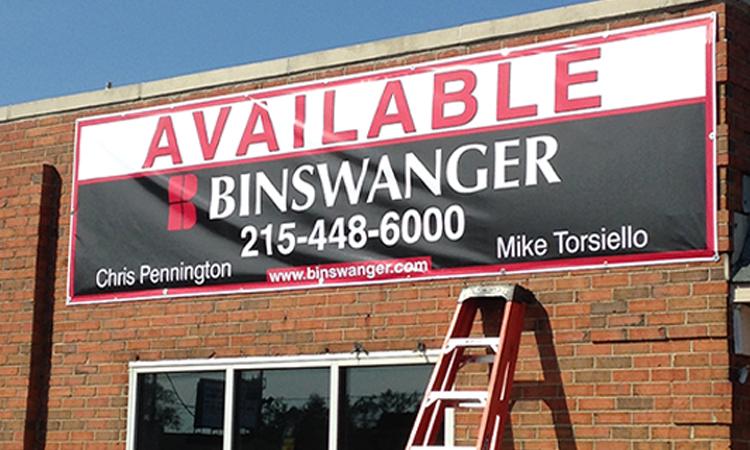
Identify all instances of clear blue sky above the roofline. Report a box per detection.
[0,0,584,106]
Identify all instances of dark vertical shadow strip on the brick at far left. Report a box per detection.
[23,165,61,450]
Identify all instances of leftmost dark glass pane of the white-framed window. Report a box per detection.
[135,372,224,450]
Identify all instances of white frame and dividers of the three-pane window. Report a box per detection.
[125,350,444,450]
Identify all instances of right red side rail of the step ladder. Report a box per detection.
[477,301,526,450]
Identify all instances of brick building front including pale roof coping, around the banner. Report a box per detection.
[0,0,750,450]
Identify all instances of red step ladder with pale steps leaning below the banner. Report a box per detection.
[406,284,533,450]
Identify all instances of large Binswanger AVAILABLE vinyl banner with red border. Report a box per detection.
[69,16,716,303]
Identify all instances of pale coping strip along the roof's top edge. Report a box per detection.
[0,0,716,122]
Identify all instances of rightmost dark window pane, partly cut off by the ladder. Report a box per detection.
[338,364,432,450]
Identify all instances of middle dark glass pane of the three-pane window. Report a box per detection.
[233,368,329,450]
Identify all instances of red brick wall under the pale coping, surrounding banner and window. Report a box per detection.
[0,0,750,450]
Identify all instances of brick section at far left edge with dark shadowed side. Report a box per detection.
[0,164,60,450]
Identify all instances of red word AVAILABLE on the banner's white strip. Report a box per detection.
[143,48,602,169]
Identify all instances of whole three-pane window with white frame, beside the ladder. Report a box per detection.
[127,352,435,450]
